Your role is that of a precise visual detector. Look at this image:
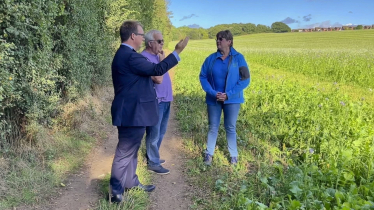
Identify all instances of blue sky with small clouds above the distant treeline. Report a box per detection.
[169,0,374,29]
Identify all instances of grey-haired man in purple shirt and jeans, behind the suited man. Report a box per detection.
[141,30,173,174]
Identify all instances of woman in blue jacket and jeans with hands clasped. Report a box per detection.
[200,30,250,165]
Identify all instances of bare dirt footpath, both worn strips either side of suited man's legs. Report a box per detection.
[21,106,192,210]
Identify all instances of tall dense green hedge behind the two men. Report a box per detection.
[0,0,172,148]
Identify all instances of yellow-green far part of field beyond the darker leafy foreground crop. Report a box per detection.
[179,30,374,89]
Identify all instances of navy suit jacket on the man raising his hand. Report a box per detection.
[111,45,178,126]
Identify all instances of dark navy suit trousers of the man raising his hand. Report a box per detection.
[110,126,145,194]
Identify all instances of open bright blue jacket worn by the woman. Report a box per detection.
[200,47,250,104]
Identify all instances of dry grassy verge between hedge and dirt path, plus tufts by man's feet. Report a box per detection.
[0,88,148,209]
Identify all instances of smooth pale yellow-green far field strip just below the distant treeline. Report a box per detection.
[187,30,374,52]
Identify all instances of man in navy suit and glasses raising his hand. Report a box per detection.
[110,21,188,202]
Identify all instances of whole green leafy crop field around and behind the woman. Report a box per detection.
[169,30,374,209]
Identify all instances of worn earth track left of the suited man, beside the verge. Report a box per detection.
[16,127,118,210]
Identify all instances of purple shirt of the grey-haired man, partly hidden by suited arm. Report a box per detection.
[141,50,173,103]
